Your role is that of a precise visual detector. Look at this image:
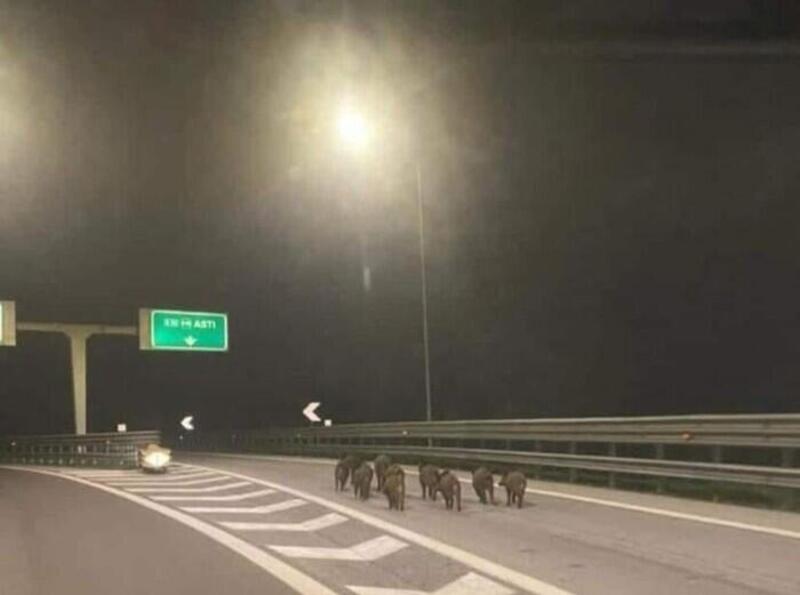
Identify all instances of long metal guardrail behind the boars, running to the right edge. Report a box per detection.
[182,414,800,489]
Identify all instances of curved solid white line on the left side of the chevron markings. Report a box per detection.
[2,466,336,595]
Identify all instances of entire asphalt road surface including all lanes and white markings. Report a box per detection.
[0,455,800,595]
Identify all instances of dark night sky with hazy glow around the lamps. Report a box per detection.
[0,0,800,433]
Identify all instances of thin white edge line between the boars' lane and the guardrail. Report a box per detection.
[196,452,800,540]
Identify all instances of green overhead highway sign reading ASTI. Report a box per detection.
[139,310,228,351]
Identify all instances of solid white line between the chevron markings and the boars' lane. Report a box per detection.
[191,465,571,595]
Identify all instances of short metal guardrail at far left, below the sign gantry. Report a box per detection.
[0,431,161,469]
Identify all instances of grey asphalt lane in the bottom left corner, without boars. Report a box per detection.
[0,468,294,595]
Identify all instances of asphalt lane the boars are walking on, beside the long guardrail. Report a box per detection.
[182,455,800,595]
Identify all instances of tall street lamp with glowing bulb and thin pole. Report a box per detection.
[337,107,433,421]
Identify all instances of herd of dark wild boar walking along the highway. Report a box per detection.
[334,455,527,510]
